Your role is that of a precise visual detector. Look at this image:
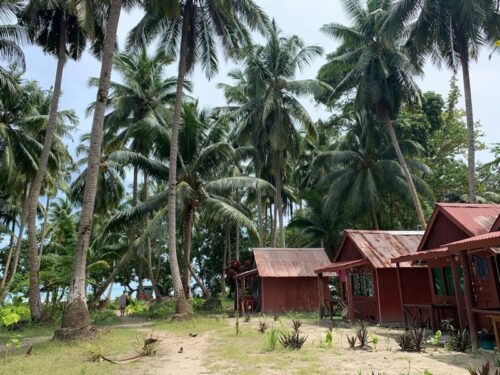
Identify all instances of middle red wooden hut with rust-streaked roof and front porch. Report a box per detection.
[316,230,431,323]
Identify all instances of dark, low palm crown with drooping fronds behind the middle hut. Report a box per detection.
[309,116,432,230]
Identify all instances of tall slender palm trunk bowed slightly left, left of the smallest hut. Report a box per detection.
[168,0,192,314]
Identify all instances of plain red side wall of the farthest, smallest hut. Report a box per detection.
[261,277,326,313]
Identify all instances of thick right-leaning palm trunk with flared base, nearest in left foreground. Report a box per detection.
[56,0,122,336]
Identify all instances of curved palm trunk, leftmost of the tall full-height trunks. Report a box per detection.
[28,16,66,321]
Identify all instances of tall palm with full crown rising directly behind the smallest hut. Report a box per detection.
[222,22,328,246]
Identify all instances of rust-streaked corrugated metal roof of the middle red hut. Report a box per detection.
[346,230,424,268]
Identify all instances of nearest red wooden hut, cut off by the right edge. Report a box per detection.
[392,203,500,352]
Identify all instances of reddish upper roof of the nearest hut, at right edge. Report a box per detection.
[437,203,500,236]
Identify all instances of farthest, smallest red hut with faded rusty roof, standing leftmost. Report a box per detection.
[235,248,329,313]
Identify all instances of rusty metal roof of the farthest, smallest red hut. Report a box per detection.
[253,248,330,277]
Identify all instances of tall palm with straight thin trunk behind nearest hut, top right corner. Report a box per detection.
[385,0,500,202]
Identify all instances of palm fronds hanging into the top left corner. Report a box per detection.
[0,0,28,93]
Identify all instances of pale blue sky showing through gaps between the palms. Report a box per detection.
[20,0,500,162]
